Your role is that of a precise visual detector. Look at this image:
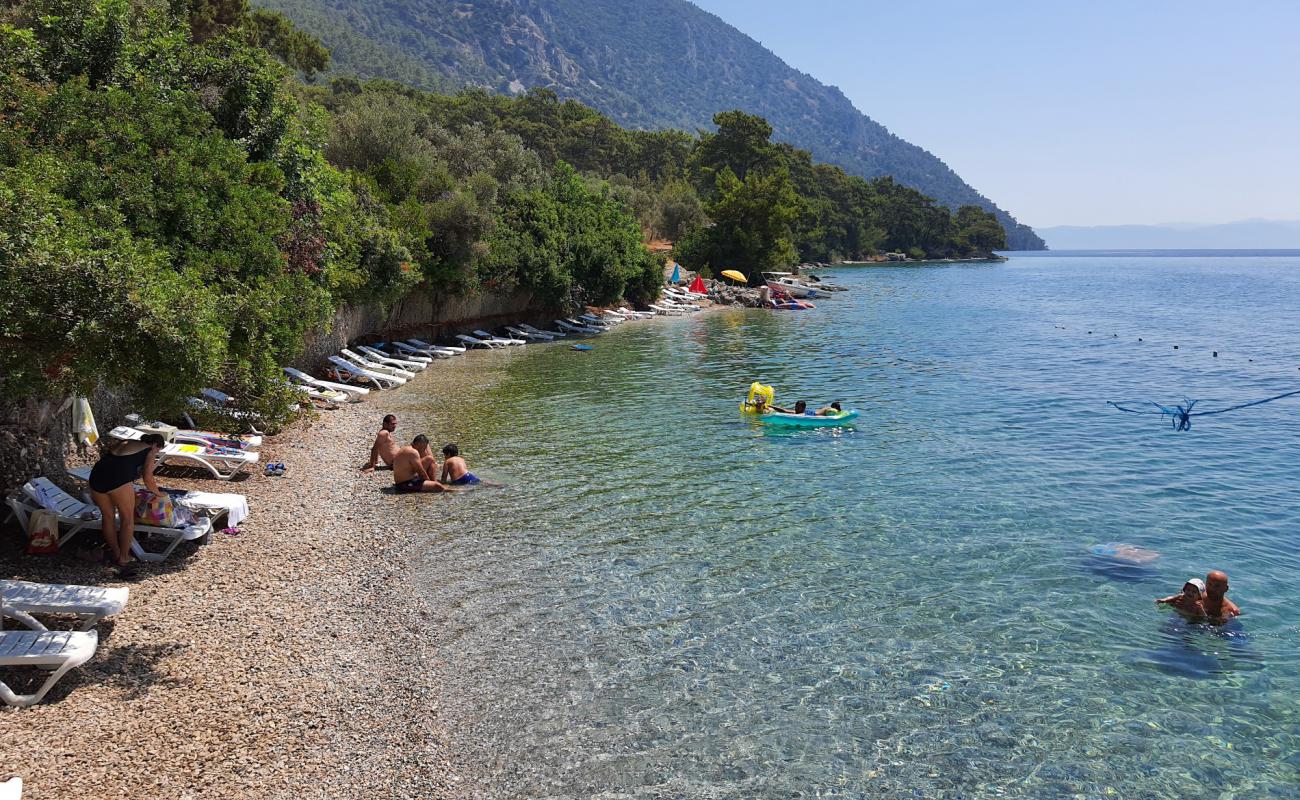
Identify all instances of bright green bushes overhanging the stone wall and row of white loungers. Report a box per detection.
[0,0,660,415]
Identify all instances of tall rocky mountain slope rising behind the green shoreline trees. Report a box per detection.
[255,0,1044,250]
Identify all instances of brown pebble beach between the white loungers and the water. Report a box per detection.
[0,354,504,800]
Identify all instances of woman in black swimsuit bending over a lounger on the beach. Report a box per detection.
[90,433,166,576]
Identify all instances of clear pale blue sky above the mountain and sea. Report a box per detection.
[693,0,1300,226]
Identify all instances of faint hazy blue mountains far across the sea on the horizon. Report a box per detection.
[1037,220,1300,250]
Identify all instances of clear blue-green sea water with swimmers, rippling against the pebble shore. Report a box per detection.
[413,256,1300,797]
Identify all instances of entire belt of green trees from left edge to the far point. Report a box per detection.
[0,0,1005,436]
